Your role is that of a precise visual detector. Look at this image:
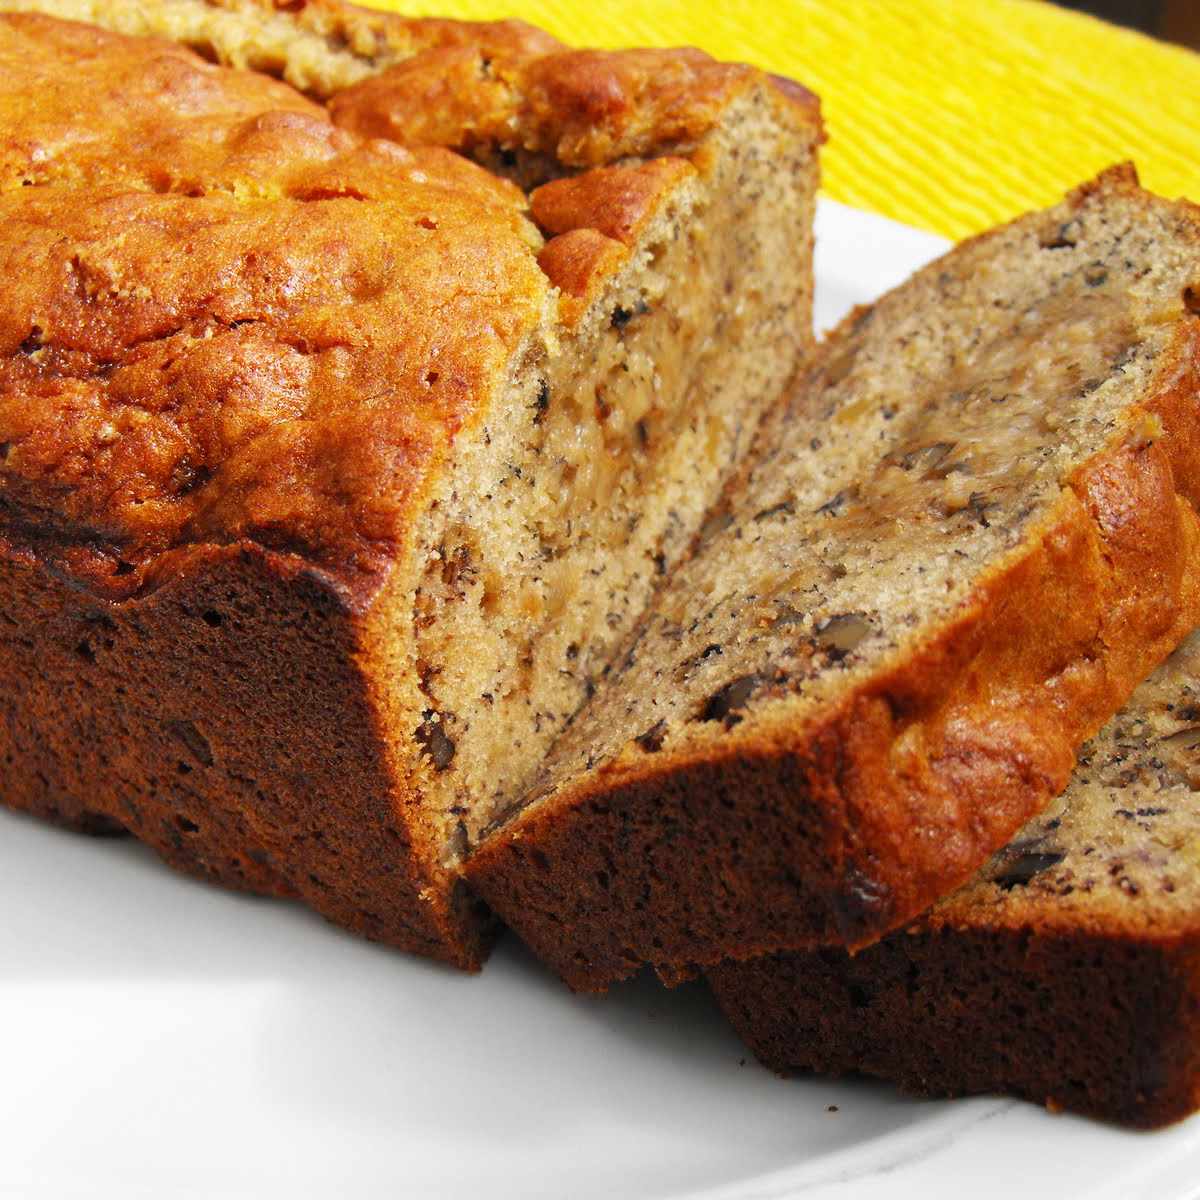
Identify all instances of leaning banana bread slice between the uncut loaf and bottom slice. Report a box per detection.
[468,168,1200,989]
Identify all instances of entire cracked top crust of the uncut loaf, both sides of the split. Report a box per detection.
[0,10,808,598]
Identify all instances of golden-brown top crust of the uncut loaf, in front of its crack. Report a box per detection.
[0,17,548,594]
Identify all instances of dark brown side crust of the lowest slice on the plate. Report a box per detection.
[707,929,1200,1128]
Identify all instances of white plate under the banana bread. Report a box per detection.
[0,204,1200,1200]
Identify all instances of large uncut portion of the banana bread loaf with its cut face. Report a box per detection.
[0,7,821,966]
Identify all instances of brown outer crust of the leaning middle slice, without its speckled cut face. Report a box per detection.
[467,229,1200,991]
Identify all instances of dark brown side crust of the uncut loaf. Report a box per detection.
[0,544,494,970]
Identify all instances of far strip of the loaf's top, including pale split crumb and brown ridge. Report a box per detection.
[0,0,820,162]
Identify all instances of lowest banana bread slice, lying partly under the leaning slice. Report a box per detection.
[708,634,1200,1126]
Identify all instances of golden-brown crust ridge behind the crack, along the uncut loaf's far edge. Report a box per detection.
[208,0,823,154]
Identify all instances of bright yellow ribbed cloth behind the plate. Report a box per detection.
[371,0,1200,238]
